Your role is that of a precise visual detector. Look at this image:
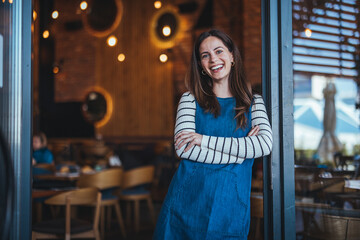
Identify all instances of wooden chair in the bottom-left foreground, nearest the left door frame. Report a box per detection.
[32,188,101,240]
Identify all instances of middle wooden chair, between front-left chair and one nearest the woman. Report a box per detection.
[77,168,126,239]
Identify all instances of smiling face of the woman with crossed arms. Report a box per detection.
[199,36,234,82]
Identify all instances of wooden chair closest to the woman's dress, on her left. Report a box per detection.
[120,166,156,232]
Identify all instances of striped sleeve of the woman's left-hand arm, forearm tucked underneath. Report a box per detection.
[174,92,244,164]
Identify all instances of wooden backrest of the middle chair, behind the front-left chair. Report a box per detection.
[76,168,123,190]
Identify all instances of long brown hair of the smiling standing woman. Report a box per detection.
[185,30,253,128]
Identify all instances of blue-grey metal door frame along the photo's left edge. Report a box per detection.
[7,0,32,240]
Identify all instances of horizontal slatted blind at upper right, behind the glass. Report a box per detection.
[293,0,360,82]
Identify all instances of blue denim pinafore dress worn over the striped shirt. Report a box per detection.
[153,98,254,240]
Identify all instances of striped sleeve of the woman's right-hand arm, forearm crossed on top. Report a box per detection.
[201,95,273,159]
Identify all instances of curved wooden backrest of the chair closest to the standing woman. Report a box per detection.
[122,166,155,189]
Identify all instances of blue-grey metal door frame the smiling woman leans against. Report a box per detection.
[261,0,296,240]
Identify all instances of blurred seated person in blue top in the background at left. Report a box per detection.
[32,133,54,174]
